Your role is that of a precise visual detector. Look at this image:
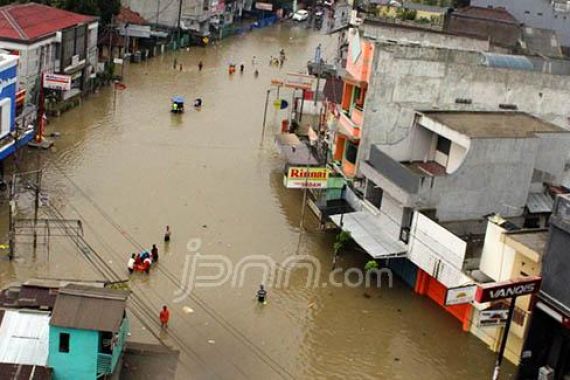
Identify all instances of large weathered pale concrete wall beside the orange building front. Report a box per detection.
[359,43,570,185]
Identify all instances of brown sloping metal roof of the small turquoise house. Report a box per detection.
[50,284,128,332]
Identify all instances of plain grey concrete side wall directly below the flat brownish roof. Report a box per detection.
[418,138,539,221]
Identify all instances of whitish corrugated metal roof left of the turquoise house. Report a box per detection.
[0,310,50,366]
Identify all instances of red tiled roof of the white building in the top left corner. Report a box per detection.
[0,3,96,42]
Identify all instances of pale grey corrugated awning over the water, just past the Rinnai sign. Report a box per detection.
[331,211,406,259]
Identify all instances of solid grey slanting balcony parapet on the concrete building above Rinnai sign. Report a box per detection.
[368,145,423,194]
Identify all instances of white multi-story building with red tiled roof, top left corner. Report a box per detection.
[0,3,98,103]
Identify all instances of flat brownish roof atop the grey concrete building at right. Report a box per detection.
[420,110,569,138]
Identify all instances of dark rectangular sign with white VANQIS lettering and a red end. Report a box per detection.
[475,276,542,303]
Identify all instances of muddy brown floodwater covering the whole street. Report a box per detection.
[1,24,514,380]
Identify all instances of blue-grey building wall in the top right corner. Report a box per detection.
[471,0,570,46]
